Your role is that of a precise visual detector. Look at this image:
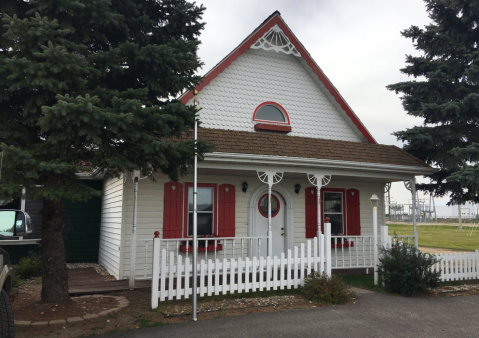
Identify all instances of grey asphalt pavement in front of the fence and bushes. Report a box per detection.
[94,293,479,338]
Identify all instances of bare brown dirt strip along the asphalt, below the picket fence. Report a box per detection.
[15,289,347,338]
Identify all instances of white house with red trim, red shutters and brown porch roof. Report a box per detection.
[99,12,433,279]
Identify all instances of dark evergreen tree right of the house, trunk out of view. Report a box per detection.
[387,0,479,204]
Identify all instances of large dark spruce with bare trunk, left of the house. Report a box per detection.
[0,0,209,302]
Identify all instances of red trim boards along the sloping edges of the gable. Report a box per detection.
[180,11,377,144]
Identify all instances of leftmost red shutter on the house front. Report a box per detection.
[163,182,183,238]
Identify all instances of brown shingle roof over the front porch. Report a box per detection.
[198,128,430,168]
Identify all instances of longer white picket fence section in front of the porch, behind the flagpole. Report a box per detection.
[151,227,331,309]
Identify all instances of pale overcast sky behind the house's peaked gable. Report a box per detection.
[193,0,448,205]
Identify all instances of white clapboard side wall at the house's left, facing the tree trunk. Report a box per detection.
[98,177,124,278]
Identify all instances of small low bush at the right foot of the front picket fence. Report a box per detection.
[301,272,354,304]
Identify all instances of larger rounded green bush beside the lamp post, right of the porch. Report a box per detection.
[378,238,441,296]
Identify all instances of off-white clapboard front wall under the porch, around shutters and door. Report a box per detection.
[122,175,384,278]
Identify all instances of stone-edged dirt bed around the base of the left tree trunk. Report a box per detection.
[10,284,118,322]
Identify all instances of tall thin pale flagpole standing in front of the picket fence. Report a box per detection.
[192,90,199,322]
